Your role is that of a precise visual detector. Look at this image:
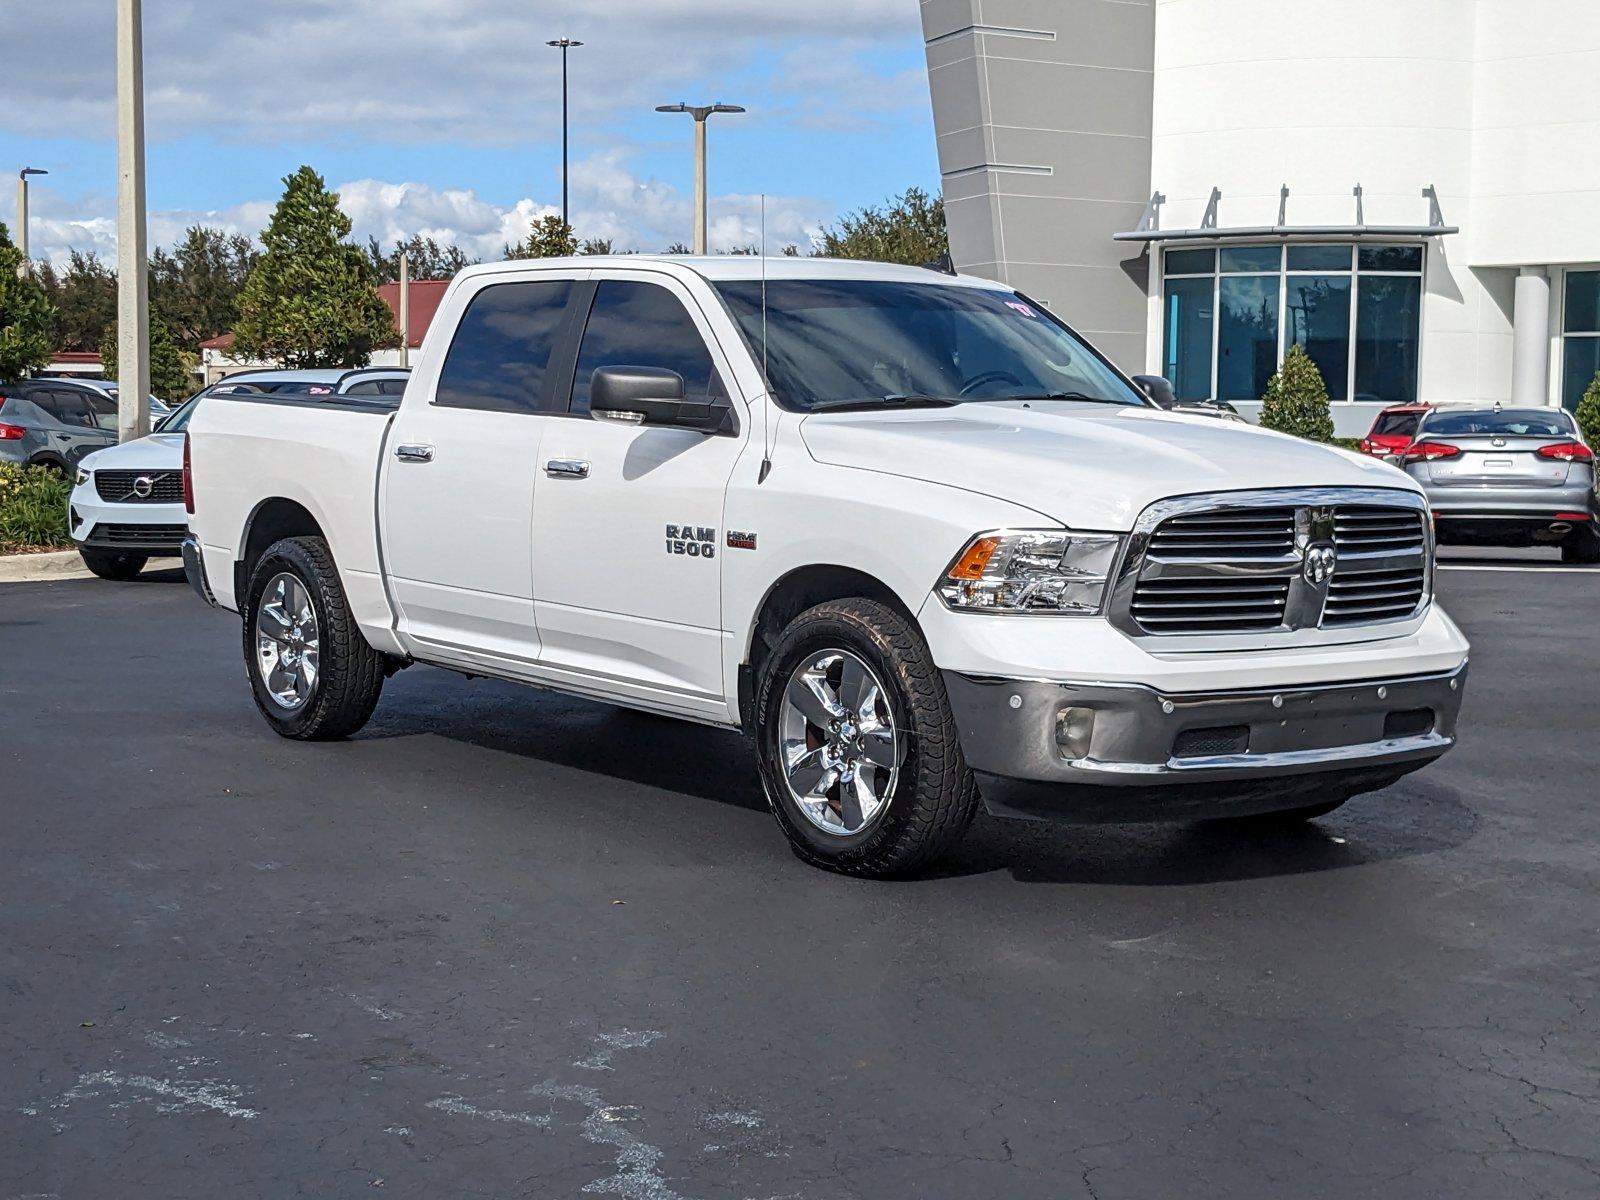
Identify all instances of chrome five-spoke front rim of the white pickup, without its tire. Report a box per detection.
[778,650,904,837]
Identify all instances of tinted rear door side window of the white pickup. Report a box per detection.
[435,280,573,413]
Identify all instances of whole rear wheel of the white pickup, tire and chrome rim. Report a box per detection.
[243,538,384,741]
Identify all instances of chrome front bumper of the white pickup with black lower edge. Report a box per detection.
[944,662,1467,819]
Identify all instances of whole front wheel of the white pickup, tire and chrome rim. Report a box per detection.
[755,598,978,878]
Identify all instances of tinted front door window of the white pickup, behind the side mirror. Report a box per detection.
[571,280,726,413]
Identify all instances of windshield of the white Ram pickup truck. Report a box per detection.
[717,280,1149,410]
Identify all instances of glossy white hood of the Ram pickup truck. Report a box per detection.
[800,400,1419,531]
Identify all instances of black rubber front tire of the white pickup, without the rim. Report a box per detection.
[755,598,978,878]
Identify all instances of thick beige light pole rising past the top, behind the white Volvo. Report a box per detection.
[117,0,150,442]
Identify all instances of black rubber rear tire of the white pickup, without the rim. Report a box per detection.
[243,538,384,741]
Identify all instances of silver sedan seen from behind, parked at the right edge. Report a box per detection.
[1400,405,1600,563]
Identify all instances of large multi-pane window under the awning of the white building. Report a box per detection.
[1162,242,1427,403]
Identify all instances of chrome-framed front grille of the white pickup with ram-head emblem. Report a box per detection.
[1110,488,1432,637]
